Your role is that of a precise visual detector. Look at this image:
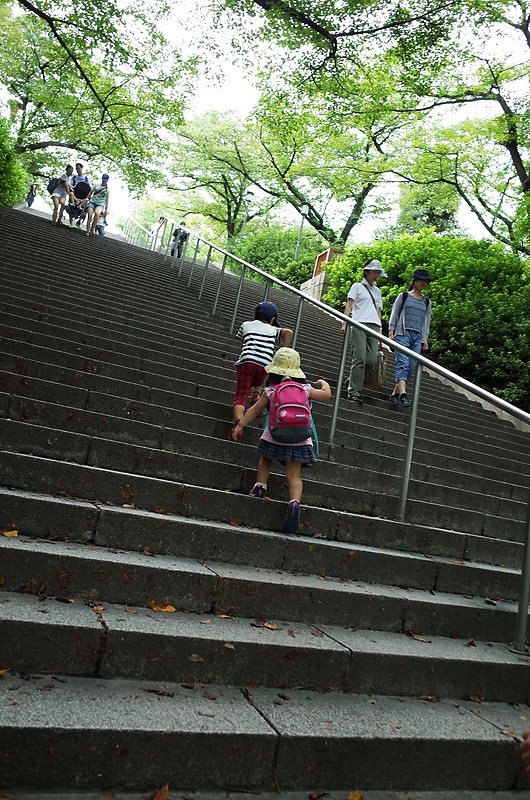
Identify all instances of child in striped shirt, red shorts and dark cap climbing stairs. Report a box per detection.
[232,301,293,424]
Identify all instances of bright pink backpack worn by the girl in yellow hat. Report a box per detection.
[269,378,311,444]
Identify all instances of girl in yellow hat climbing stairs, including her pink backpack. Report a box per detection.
[231,347,331,533]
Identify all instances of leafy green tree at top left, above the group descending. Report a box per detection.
[0,0,191,189]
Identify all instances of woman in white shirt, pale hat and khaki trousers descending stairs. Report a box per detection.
[341,258,387,405]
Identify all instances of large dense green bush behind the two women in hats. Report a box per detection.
[325,231,530,411]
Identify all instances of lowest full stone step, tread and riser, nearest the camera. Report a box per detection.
[0,675,524,792]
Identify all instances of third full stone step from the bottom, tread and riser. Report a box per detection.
[0,536,517,642]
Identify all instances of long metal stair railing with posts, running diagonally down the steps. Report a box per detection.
[121,222,530,655]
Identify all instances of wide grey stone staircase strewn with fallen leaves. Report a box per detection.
[0,208,530,800]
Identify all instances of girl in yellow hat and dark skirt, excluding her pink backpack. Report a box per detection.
[231,347,331,533]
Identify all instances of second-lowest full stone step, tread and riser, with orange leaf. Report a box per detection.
[4,592,530,703]
